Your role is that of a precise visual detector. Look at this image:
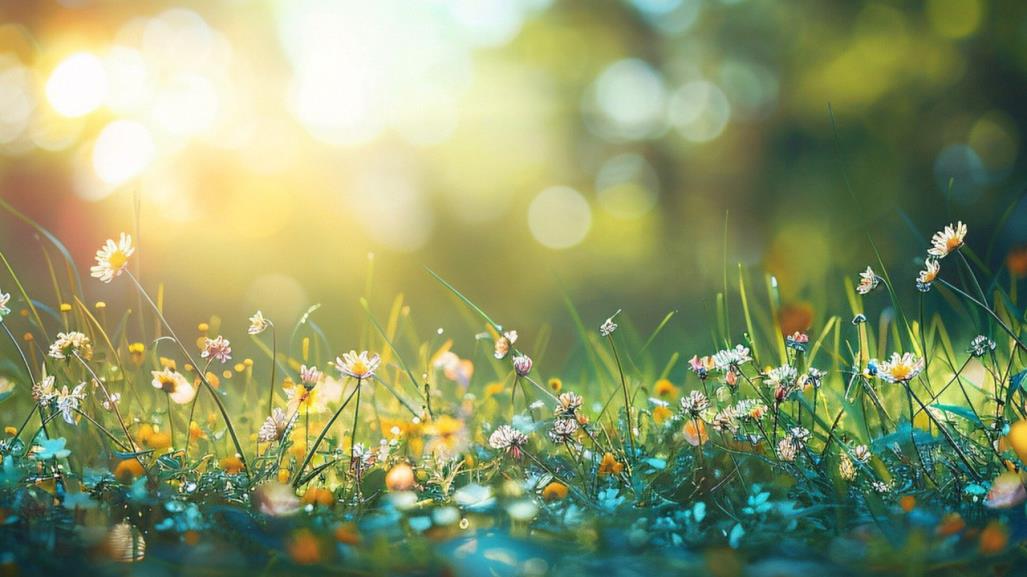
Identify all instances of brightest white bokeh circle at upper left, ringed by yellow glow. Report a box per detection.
[46,52,107,118]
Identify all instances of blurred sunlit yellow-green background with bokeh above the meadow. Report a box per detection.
[0,0,1027,359]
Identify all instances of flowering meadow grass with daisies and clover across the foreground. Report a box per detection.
[0,203,1027,575]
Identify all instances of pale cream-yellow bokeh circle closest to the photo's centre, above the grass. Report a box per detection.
[528,186,592,249]
